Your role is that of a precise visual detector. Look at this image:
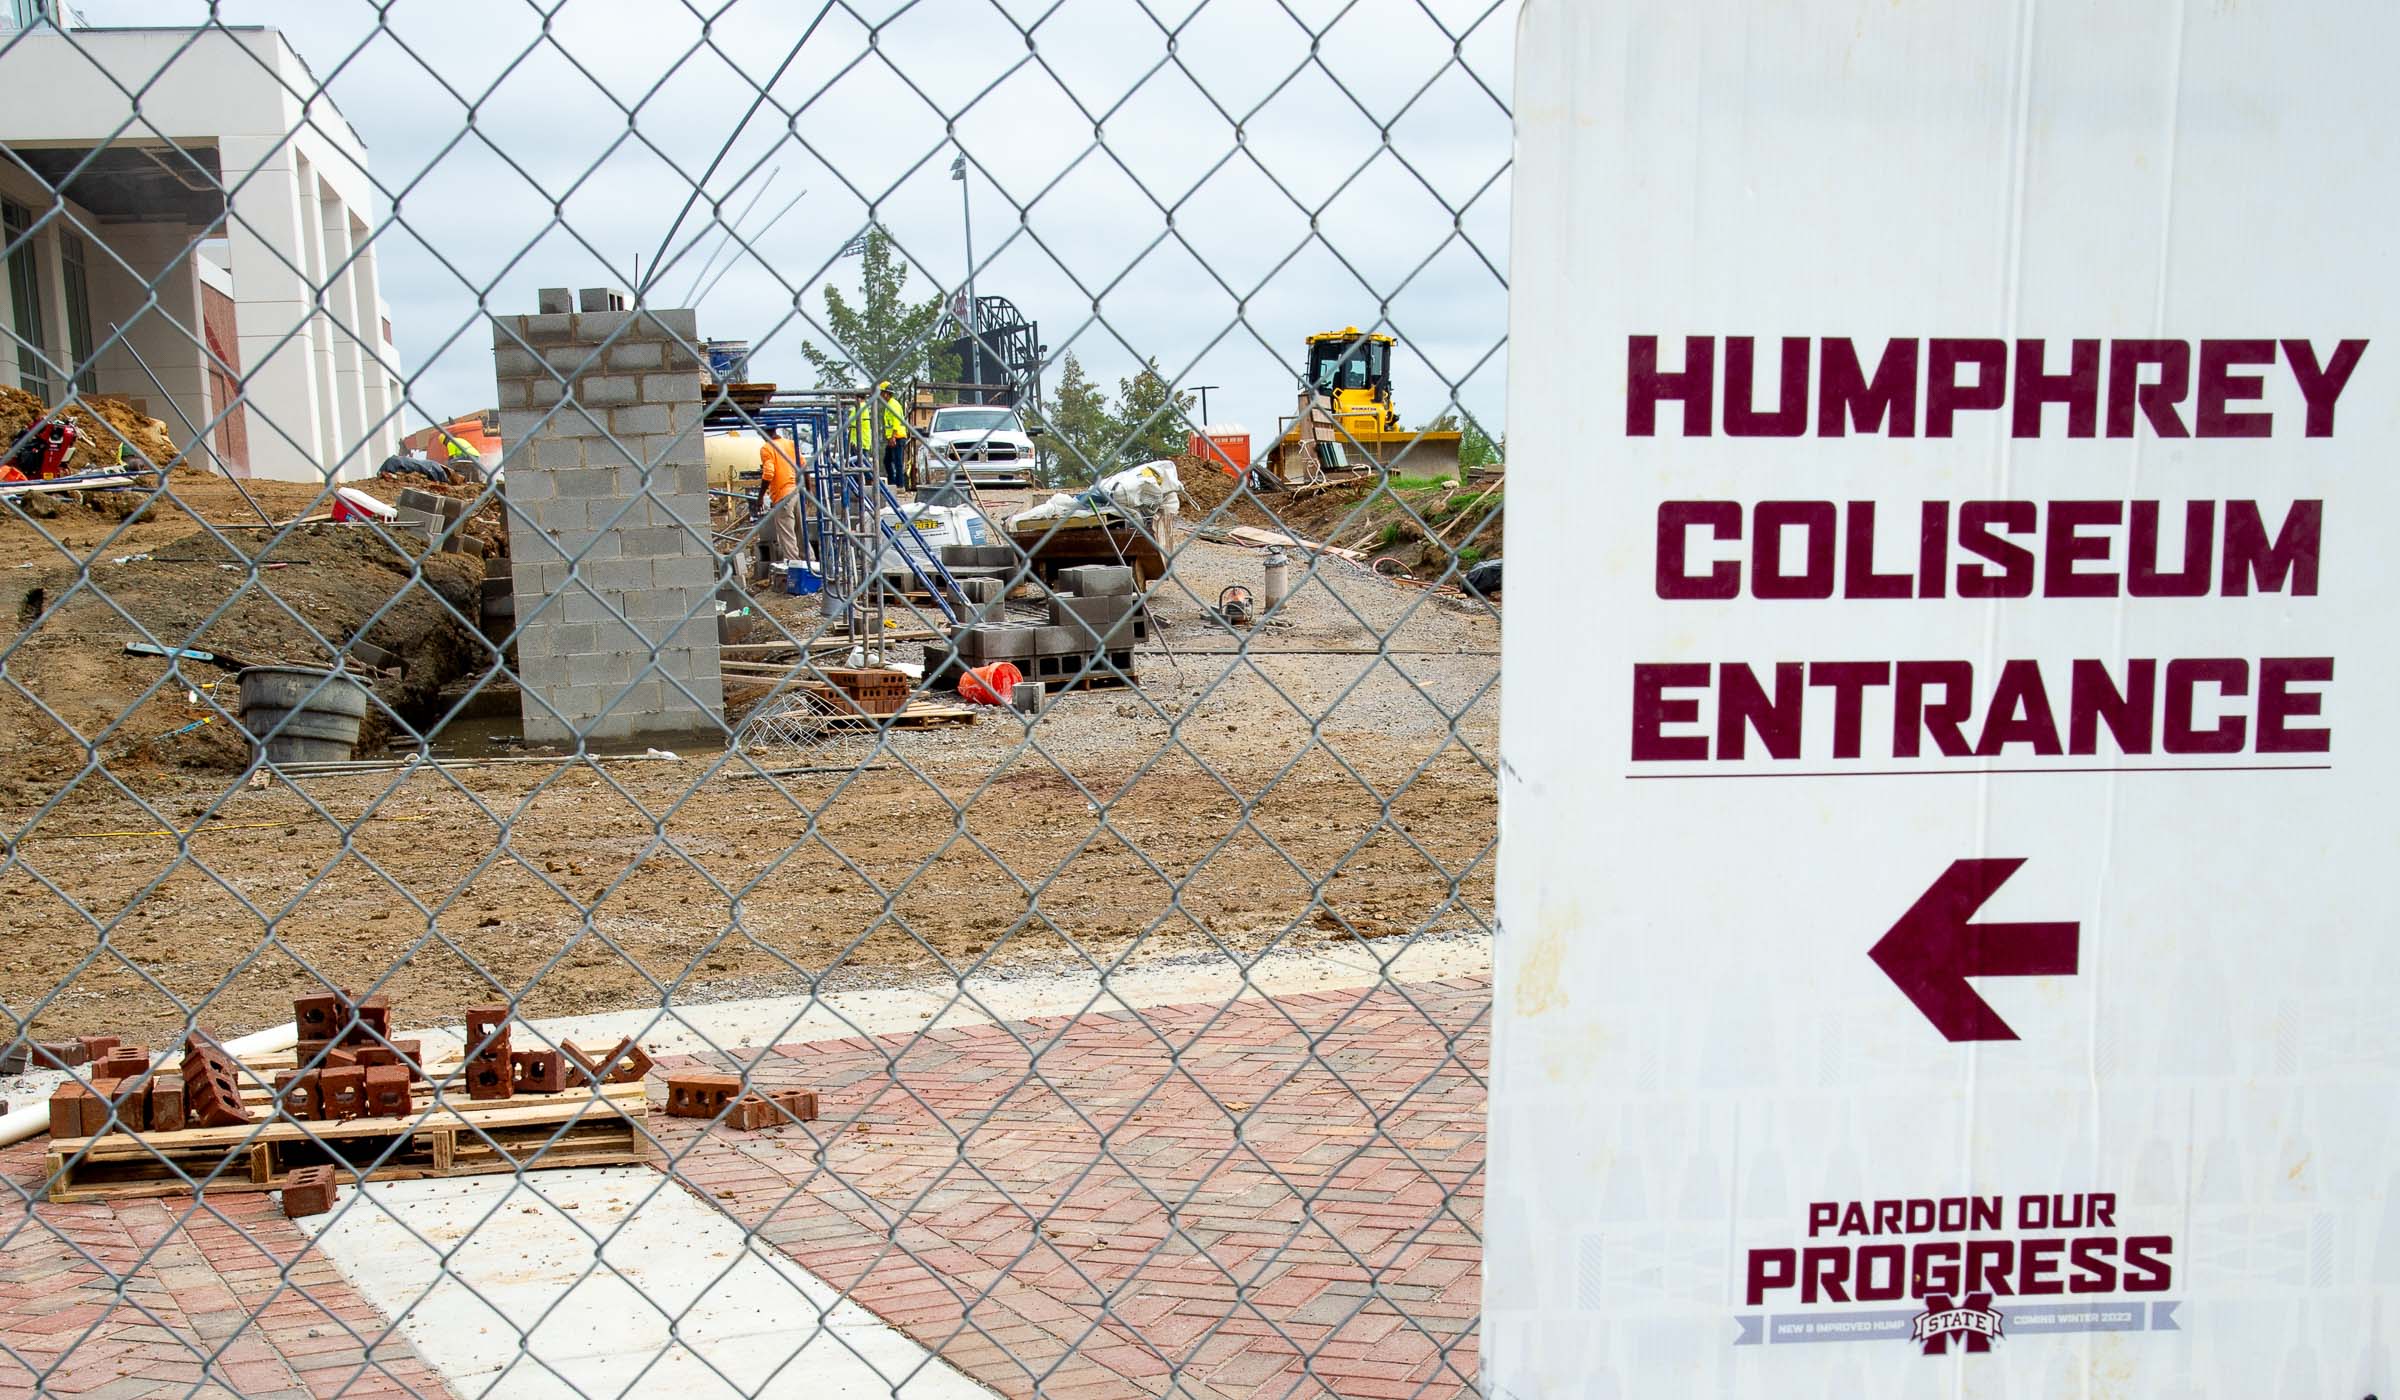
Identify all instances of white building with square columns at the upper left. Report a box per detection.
[0,29,398,480]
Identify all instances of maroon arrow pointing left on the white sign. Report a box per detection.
[1867,860,2081,1040]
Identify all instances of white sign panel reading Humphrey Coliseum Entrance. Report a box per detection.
[1483,0,2400,1400]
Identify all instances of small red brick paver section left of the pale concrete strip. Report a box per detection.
[0,1138,449,1400]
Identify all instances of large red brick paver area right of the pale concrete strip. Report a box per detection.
[650,980,1490,1400]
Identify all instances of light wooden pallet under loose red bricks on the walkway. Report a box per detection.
[48,1054,650,1201]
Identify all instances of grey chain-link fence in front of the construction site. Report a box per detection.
[0,0,1514,1398]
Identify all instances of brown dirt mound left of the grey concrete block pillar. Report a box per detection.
[0,526,485,800]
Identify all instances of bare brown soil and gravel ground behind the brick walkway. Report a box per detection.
[0,478,1500,1040]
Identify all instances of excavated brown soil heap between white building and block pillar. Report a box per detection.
[0,473,487,802]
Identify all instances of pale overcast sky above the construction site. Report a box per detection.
[77,0,1514,449]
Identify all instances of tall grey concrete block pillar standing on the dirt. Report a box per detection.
[492,288,725,744]
